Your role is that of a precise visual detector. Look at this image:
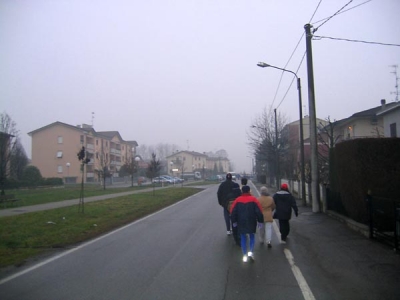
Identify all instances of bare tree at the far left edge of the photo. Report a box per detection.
[0,112,18,195]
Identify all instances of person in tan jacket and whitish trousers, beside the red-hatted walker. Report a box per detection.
[258,186,275,248]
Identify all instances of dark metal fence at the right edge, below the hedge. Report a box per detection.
[366,196,400,251]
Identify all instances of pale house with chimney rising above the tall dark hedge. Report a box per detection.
[333,99,400,142]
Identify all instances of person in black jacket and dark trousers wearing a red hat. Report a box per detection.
[273,183,299,243]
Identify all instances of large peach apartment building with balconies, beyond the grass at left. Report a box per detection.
[28,122,138,183]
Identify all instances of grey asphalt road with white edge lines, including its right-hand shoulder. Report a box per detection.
[0,185,400,300]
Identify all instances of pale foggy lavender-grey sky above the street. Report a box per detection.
[0,0,400,172]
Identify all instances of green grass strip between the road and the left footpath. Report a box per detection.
[0,187,200,268]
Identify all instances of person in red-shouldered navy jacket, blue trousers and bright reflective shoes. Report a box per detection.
[231,185,264,262]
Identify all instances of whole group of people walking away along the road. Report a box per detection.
[217,173,298,262]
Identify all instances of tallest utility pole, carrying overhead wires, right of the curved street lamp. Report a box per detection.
[304,24,320,212]
